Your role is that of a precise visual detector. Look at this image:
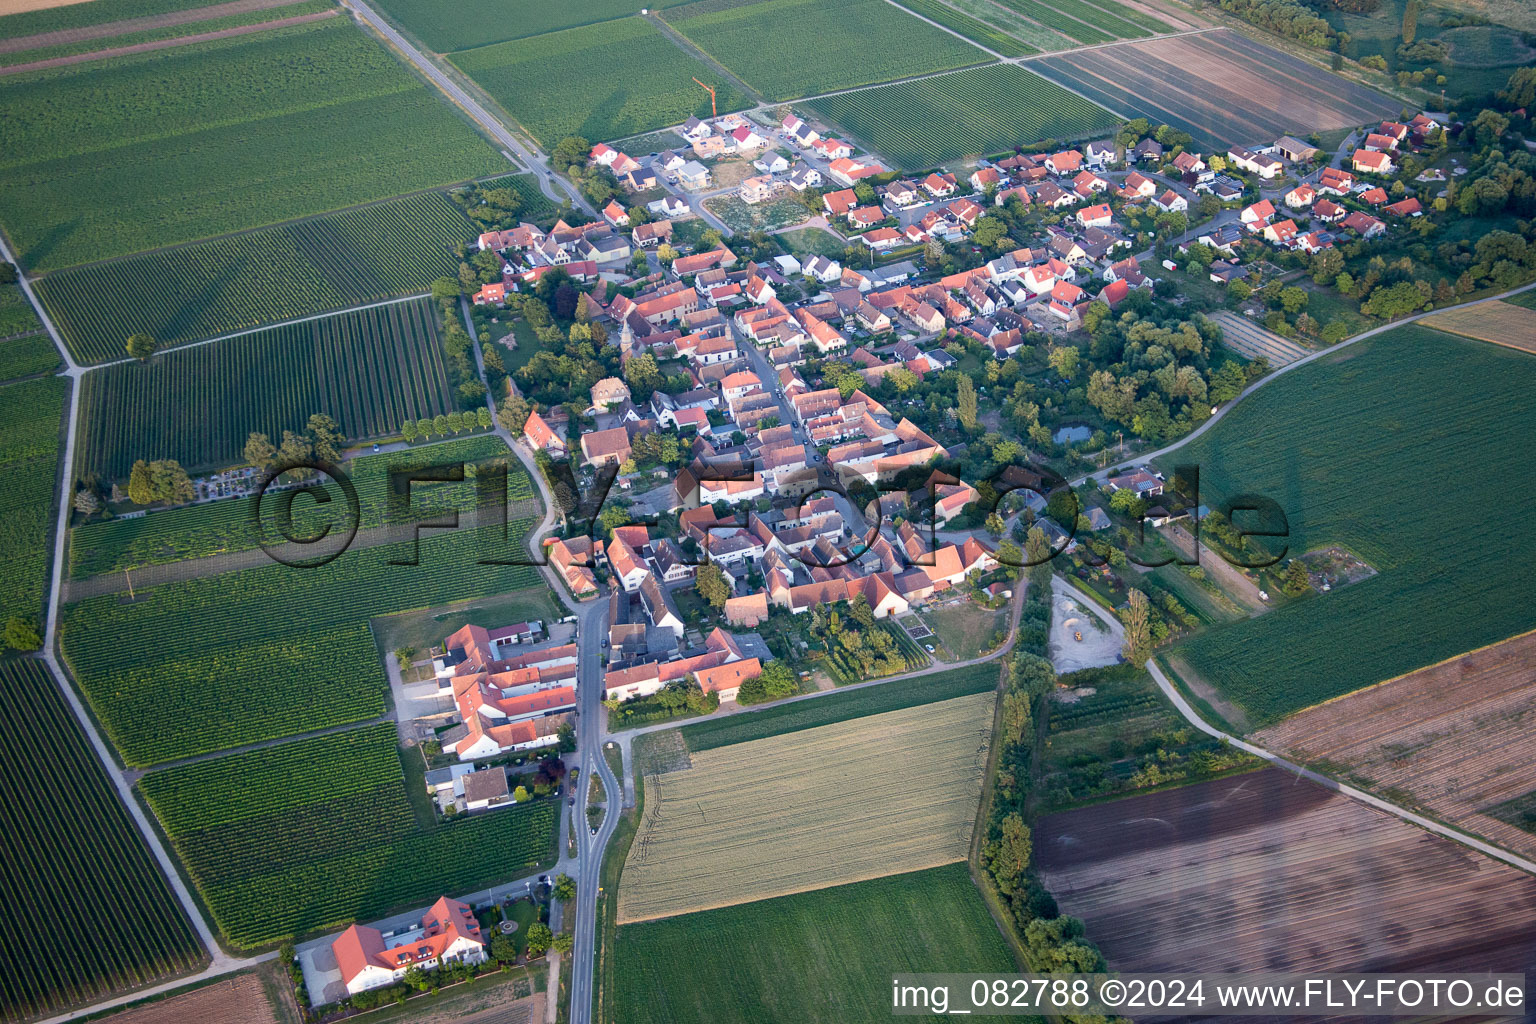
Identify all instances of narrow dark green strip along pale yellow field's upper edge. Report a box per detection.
[680,662,998,751]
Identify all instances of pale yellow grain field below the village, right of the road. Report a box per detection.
[619,692,995,924]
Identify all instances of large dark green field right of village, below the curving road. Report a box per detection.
[1161,325,1536,728]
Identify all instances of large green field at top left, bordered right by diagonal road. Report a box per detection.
[0,18,507,270]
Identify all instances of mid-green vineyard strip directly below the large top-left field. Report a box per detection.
[35,192,476,362]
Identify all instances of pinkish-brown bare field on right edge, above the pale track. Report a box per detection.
[1255,633,1536,857]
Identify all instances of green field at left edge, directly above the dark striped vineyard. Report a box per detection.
[0,376,69,633]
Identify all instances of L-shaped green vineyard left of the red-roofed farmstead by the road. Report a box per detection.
[60,519,544,766]
